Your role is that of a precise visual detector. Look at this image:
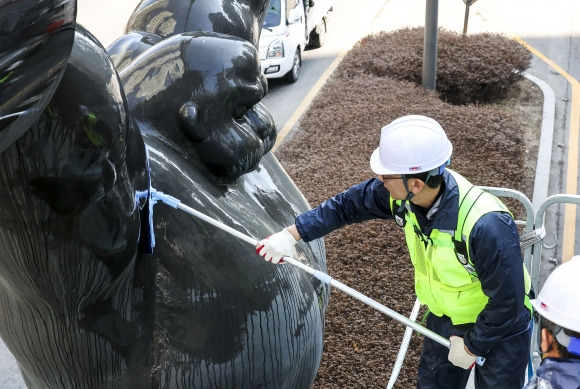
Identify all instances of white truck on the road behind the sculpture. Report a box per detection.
[260,0,334,82]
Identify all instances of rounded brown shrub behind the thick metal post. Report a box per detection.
[338,27,532,104]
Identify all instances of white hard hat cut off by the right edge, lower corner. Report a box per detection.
[531,255,580,332]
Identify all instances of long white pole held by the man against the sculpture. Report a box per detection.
[151,188,485,364]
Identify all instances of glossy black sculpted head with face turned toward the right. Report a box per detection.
[121,32,276,183]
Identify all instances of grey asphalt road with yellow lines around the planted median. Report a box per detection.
[0,0,580,389]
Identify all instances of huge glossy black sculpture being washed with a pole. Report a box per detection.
[0,0,328,388]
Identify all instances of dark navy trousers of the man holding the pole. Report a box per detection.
[417,309,530,389]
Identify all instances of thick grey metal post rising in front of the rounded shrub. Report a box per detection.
[423,0,439,90]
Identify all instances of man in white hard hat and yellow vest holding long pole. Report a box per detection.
[256,115,531,389]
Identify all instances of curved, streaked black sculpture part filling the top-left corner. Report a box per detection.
[0,0,76,151]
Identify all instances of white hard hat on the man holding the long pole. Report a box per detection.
[371,115,453,174]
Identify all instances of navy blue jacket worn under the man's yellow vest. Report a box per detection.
[295,171,530,356]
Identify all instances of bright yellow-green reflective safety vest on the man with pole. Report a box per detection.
[390,169,531,325]
